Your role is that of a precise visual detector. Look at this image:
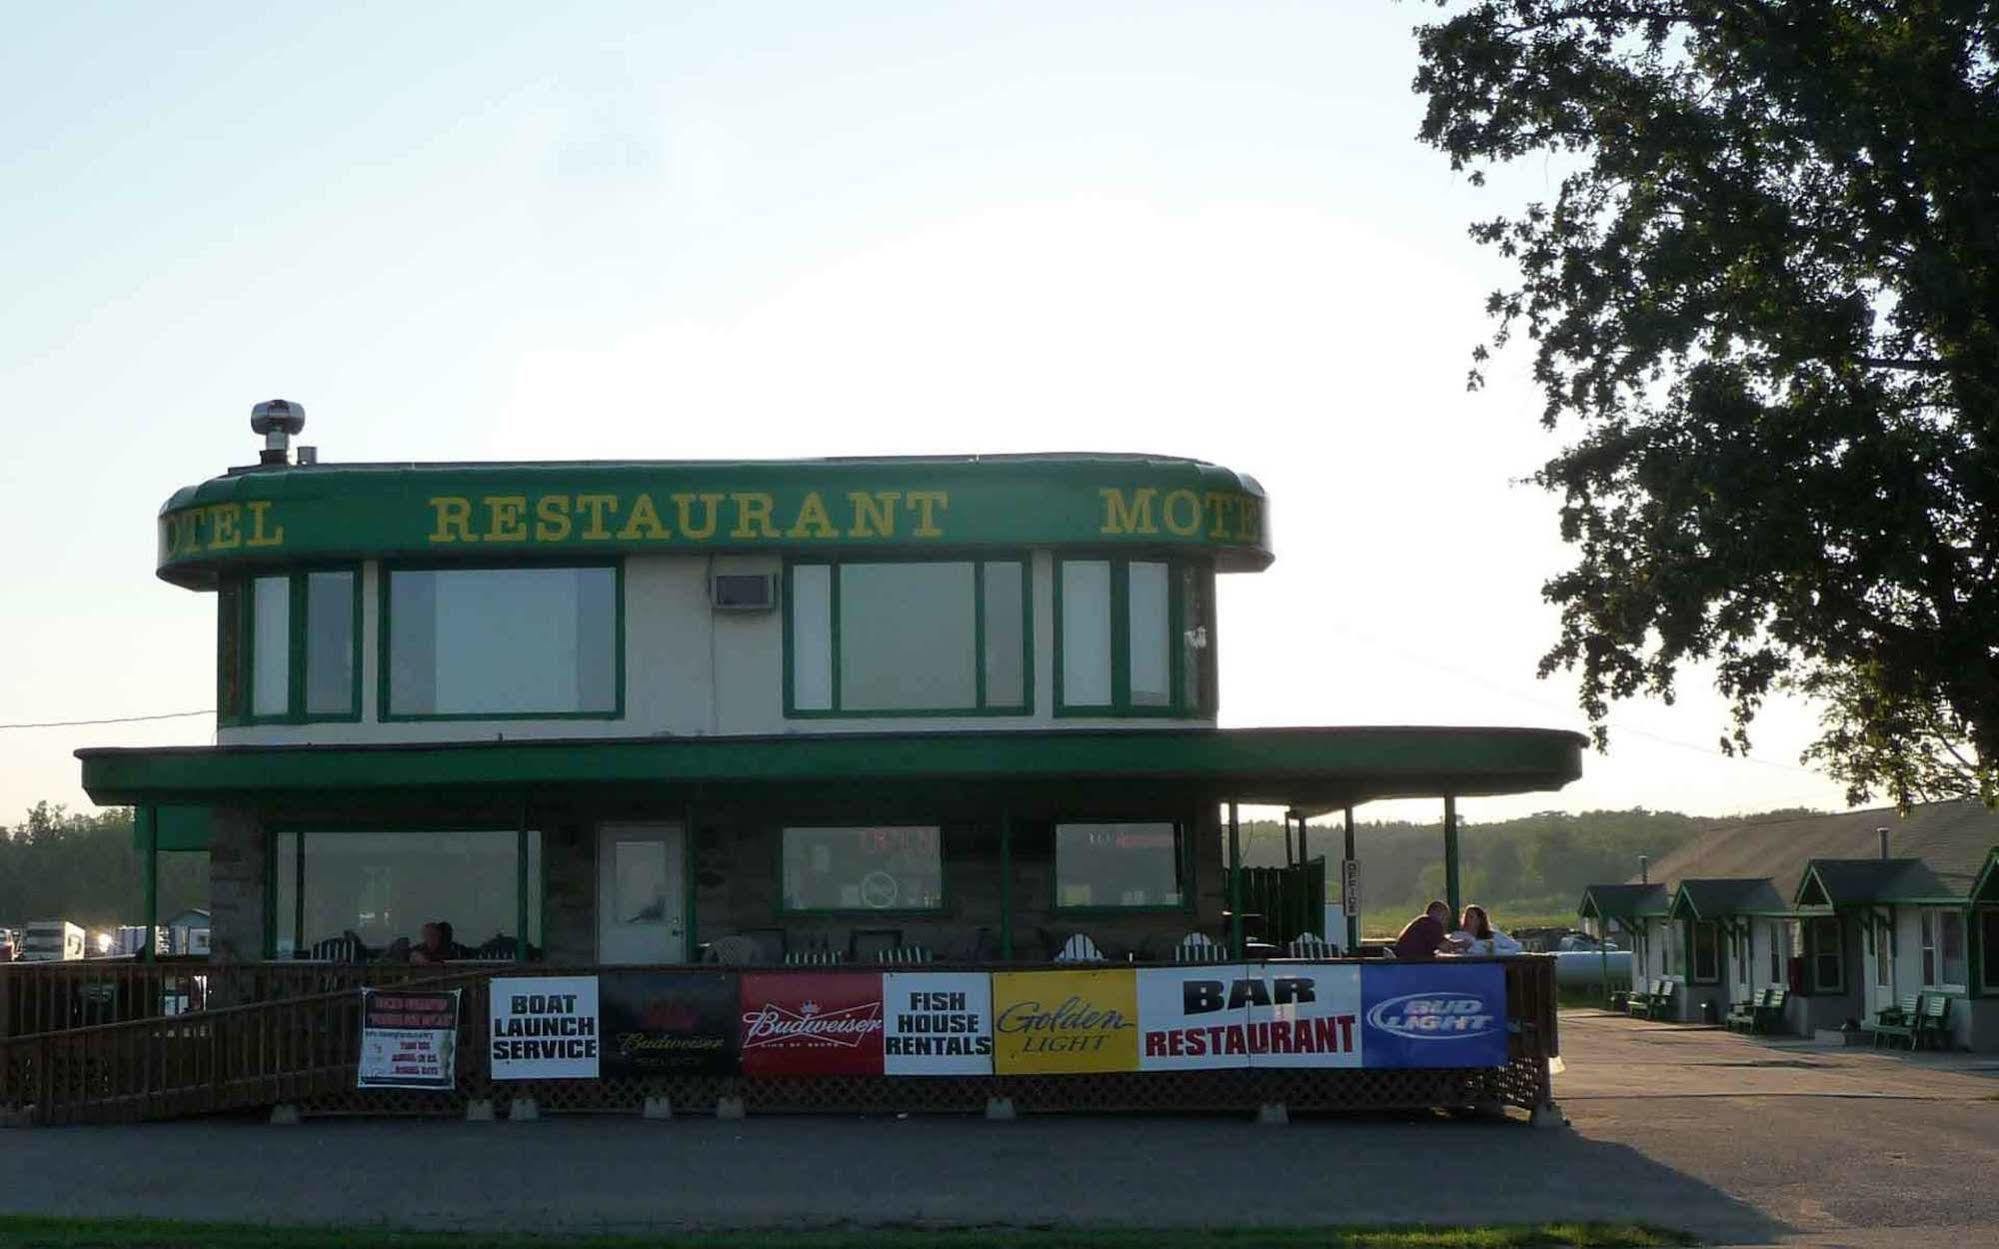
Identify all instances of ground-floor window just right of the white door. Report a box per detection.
[784,825,944,911]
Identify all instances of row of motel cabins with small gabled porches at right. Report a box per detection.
[1577,801,1999,1051]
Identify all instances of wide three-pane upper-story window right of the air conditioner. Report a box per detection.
[784,560,1031,715]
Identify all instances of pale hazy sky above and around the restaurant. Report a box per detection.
[0,0,1843,821]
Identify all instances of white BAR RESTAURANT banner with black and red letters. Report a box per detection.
[1137,963,1361,1071]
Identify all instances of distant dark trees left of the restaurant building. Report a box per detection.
[0,801,208,929]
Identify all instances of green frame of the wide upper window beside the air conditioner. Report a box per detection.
[782,552,1033,719]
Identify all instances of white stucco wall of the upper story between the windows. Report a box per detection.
[216,550,1219,745]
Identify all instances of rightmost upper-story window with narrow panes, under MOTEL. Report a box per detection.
[1055,558,1215,715]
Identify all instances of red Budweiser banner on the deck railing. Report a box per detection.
[740,971,882,1075]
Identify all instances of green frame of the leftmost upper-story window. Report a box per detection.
[216,564,362,725]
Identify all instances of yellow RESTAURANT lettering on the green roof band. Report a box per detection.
[419,490,952,543]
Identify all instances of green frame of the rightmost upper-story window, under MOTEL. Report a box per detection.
[1053,554,1217,717]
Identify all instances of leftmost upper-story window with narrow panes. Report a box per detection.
[216,568,362,723]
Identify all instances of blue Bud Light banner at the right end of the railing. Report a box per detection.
[1361,959,1507,1067]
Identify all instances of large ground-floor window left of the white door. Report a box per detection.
[272,829,542,961]
